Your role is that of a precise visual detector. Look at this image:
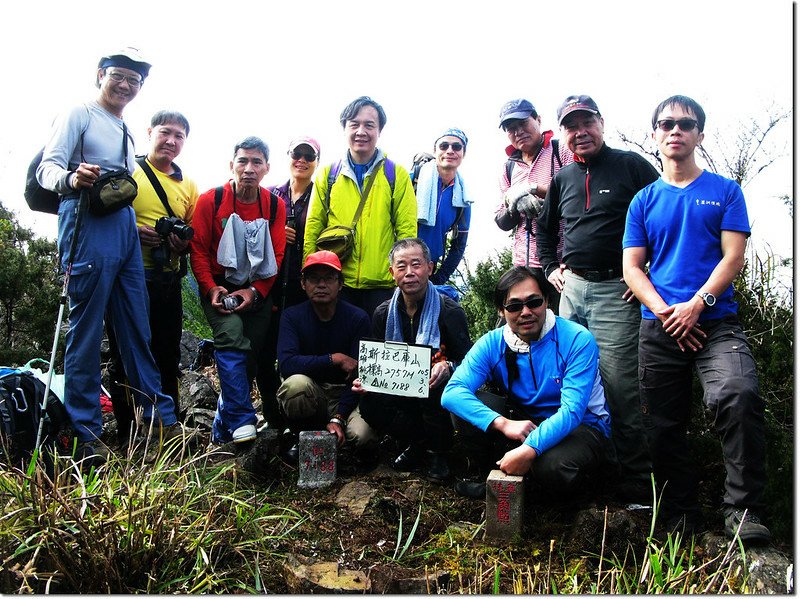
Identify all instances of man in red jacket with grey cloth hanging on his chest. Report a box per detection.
[191,137,286,443]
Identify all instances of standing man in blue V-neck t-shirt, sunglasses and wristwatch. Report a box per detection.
[622,96,771,543]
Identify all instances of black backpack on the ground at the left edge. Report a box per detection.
[0,368,74,463]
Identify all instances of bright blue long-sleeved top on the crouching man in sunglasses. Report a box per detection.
[442,317,611,454]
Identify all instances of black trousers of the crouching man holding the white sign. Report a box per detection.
[359,388,453,451]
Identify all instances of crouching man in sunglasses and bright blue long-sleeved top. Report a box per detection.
[442,266,610,499]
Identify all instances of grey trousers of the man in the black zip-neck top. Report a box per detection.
[559,270,652,484]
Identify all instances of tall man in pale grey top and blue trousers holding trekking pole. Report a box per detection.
[36,48,182,463]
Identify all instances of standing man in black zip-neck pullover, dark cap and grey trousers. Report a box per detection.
[536,95,658,504]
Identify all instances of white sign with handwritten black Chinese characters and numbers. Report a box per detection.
[358,339,431,397]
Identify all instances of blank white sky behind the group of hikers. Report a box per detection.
[0,0,794,266]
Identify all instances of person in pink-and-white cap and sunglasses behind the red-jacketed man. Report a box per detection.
[256,137,319,430]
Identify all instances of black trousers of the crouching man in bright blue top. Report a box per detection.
[453,392,611,500]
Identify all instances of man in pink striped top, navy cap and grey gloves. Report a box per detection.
[494,98,572,313]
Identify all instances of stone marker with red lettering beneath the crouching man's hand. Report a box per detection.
[486,470,525,542]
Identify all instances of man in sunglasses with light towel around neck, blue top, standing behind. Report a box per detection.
[416,128,472,286]
